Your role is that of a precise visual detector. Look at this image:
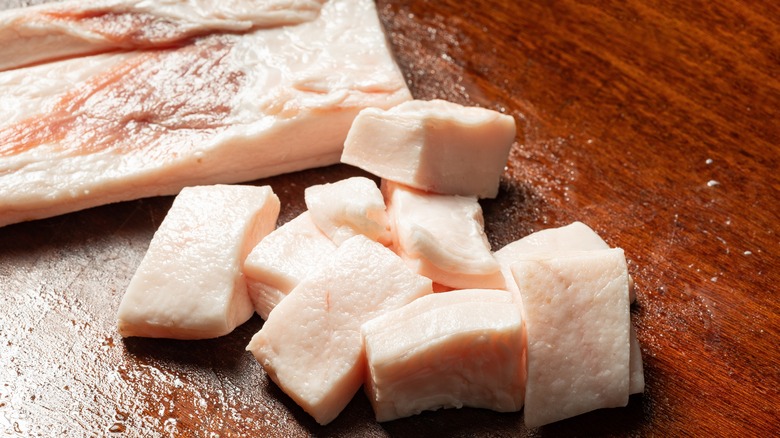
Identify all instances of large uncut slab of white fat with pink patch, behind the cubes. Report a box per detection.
[0,0,411,225]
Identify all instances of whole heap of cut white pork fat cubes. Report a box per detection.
[118,100,644,427]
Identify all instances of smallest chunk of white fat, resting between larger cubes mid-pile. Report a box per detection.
[305,176,392,246]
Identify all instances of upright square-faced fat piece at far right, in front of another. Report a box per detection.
[511,249,631,427]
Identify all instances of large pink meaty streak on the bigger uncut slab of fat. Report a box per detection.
[0,35,243,158]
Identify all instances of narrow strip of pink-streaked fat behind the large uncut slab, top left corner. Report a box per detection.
[0,0,324,70]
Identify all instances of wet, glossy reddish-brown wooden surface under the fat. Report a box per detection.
[0,0,780,437]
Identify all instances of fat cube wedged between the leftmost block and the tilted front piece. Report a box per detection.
[244,211,336,319]
